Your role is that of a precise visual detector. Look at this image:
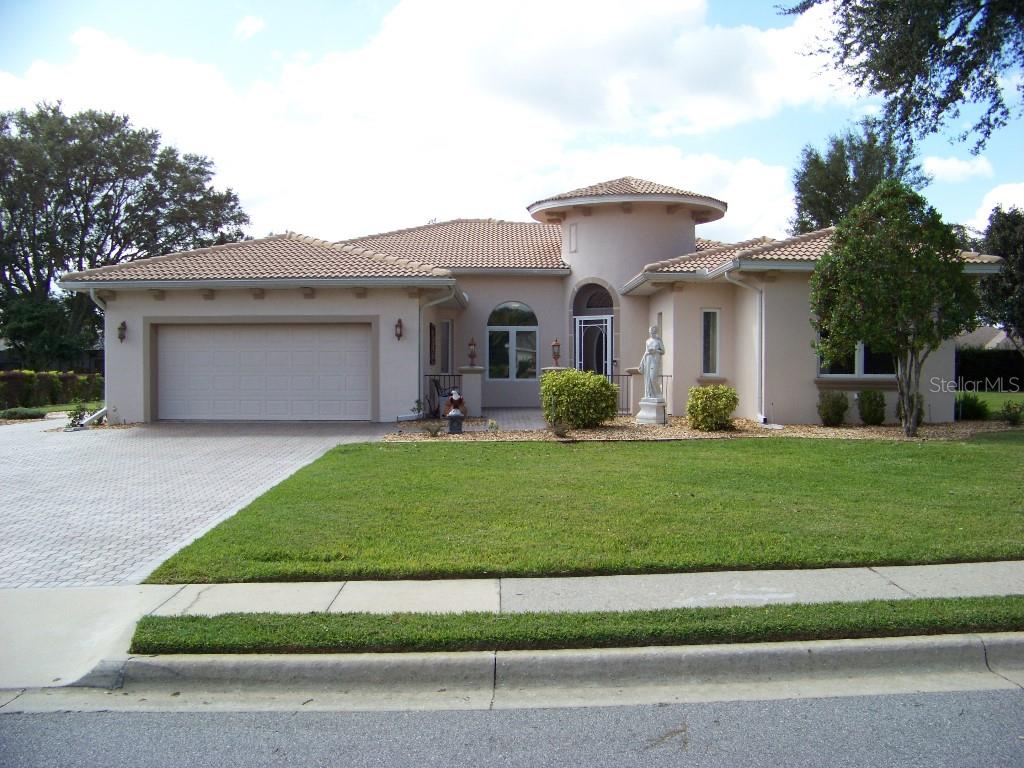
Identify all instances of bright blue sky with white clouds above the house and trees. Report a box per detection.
[0,0,1024,240]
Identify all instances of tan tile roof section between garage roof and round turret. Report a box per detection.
[339,219,568,270]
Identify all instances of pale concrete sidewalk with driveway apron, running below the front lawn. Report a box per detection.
[0,561,1024,689]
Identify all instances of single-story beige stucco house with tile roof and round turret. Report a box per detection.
[61,177,998,423]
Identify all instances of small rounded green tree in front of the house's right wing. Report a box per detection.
[811,181,978,436]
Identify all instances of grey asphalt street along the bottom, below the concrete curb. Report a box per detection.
[0,691,1024,768]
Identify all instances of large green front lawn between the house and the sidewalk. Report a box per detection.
[148,431,1024,583]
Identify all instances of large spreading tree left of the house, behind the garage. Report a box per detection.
[0,104,249,362]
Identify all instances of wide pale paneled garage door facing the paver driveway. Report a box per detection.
[157,324,370,421]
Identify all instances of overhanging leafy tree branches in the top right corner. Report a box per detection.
[785,0,1024,152]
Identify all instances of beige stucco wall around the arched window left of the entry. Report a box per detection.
[455,274,571,408]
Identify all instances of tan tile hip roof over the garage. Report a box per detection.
[61,232,451,283]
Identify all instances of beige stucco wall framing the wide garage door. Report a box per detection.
[103,289,419,423]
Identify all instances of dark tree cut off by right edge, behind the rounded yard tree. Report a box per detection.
[981,207,1024,354]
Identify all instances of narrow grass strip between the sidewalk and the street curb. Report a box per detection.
[131,596,1024,653]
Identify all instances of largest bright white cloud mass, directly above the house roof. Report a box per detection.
[0,0,858,239]
